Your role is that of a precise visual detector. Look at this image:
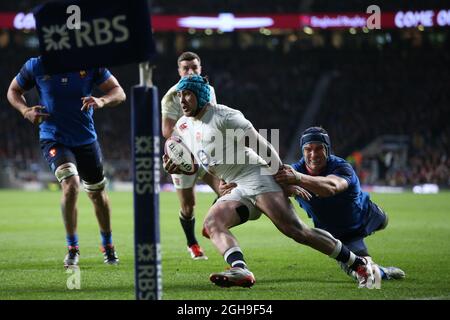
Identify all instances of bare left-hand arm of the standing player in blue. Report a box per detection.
[7,78,50,124]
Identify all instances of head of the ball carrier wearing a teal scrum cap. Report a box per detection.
[176,75,211,117]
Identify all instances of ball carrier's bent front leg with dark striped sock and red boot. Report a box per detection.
[204,201,255,287]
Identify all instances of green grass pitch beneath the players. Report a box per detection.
[0,190,450,300]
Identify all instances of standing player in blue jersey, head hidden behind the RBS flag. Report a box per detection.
[7,57,126,268]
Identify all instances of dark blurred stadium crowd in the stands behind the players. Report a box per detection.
[0,0,450,187]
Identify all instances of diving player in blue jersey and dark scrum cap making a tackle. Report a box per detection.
[275,127,405,280]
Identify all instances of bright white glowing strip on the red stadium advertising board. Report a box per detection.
[178,13,274,32]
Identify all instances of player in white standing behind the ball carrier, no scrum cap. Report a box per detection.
[161,52,219,260]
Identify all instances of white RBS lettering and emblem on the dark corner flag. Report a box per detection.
[42,15,130,51]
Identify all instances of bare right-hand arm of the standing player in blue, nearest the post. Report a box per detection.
[81,75,127,111]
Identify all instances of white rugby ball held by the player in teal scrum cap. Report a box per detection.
[164,136,198,175]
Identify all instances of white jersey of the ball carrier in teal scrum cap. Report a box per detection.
[175,104,266,182]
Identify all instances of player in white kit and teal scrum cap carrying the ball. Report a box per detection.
[164,75,381,289]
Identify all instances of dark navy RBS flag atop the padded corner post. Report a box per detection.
[34,0,155,74]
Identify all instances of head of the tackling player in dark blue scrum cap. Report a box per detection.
[300,127,331,171]
